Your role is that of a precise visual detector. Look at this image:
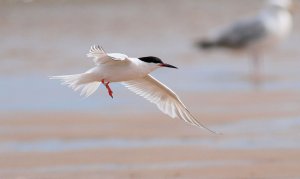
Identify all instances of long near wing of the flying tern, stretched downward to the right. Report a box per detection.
[123,75,215,133]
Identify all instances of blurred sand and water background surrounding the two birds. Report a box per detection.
[0,0,300,179]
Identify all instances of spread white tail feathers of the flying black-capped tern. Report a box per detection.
[49,73,100,97]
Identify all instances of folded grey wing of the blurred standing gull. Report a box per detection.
[216,16,267,48]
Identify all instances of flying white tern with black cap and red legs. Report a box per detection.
[50,46,215,133]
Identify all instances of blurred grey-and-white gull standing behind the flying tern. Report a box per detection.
[197,0,293,76]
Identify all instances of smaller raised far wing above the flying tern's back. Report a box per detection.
[87,45,128,65]
